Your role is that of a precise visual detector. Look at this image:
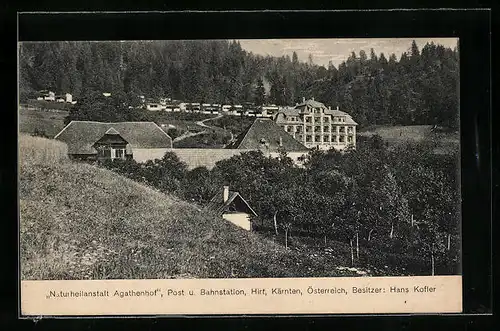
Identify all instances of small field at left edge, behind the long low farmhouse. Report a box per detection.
[19,107,68,138]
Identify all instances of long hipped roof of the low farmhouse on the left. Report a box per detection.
[54,121,172,154]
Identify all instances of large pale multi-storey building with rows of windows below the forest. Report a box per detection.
[274,98,358,150]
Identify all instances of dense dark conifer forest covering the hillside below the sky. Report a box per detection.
[19,40,459,128]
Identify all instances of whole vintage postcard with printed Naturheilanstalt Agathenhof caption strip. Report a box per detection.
[18,38,462,317]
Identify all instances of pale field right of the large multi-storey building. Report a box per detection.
[357,125,460,153]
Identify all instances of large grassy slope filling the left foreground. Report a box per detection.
[19,136,364,279]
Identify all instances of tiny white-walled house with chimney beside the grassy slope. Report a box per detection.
[207,186,257,231]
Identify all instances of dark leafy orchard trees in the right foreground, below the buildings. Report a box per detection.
[100,136,460,275]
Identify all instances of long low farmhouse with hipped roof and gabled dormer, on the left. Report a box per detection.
[54,121,172,162]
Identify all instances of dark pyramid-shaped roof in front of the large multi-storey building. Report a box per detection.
[227,118,308,152]
